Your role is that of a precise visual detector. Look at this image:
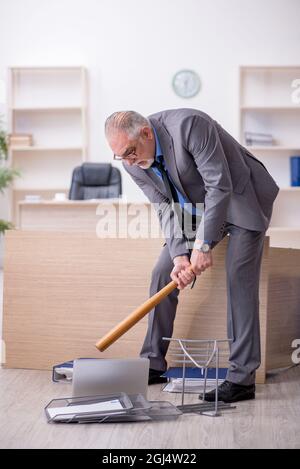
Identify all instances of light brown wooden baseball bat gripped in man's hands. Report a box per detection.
[96,280,177,352]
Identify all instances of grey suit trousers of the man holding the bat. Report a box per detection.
[140,223,265,385]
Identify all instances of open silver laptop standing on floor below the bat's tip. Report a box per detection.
[72,358,150,399]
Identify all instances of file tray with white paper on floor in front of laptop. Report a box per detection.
[45,393,133,423]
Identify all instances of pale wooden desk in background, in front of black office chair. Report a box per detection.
[18,199,161,237]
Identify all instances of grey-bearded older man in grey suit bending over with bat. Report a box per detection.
[105,109,279,402]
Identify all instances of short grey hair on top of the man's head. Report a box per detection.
[105,111,151,139]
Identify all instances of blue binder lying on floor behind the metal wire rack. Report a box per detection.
[163,367,227,394]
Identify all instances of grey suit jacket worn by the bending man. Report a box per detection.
[124,109,279,258]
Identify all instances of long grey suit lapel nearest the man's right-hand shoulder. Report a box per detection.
[148,117,189,200]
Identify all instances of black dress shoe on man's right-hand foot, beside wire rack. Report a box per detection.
[199,381,255,402]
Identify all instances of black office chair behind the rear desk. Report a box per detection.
[69,163,122,200]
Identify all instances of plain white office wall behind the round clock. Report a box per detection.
[0,0,300,208]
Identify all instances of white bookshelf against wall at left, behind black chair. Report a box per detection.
[8,66,88,223]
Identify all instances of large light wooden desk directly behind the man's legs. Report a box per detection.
[3,231,300,382]
